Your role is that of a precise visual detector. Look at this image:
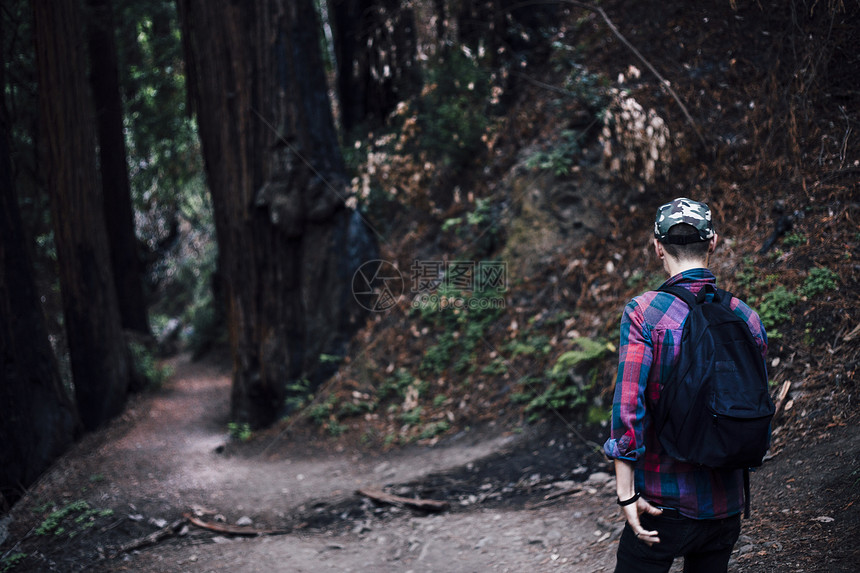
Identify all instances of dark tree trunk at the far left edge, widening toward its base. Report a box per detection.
[0,111,78,512]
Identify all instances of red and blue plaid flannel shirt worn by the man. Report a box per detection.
[603,268,767,519]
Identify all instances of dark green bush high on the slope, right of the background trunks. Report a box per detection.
[417,50,490,167]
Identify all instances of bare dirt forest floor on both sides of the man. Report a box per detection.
[0,355,860,573]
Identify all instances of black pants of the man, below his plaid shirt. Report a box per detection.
[615,510,741,573]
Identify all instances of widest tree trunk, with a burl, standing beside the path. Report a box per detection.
[179,0,375,427]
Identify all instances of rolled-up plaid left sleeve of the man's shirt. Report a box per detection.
[603,300,653,461]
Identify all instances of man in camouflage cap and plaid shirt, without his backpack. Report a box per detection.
[604,198,767,573]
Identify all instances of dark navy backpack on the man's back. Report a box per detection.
[654,285,775,516]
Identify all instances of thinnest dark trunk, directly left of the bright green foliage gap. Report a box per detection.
[87,0,150,334]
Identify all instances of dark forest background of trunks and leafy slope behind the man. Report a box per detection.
[0,0,860,507]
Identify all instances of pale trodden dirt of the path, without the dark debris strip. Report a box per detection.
[84,356,620,573]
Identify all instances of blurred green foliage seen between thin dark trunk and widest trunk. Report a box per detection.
[114,0,217,358]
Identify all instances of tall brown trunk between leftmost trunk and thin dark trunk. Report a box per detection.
[33,0,130,430]
